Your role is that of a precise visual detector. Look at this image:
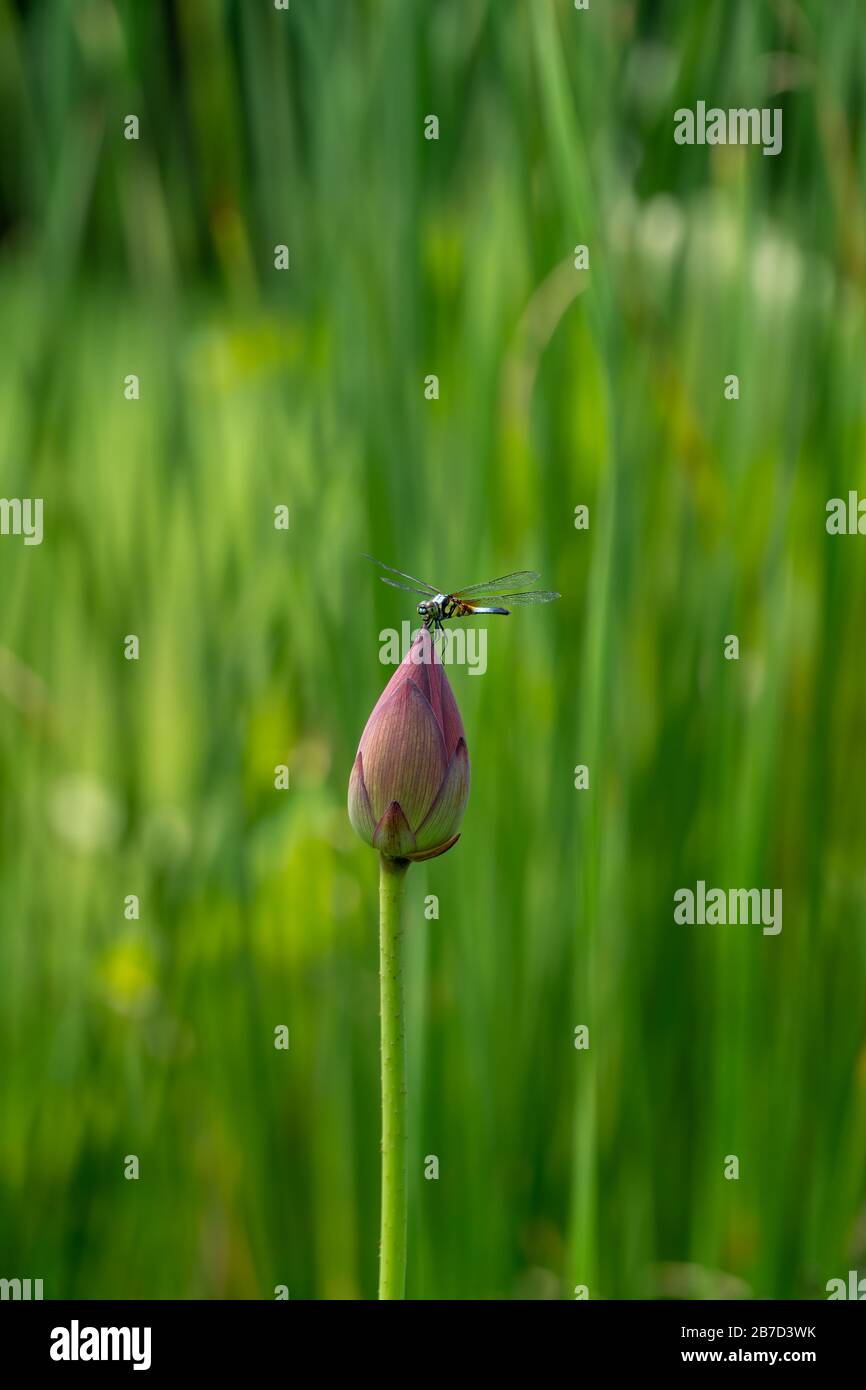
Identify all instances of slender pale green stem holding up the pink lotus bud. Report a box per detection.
[379,855,409,1298]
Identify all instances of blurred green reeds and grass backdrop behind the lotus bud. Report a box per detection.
[0,0,866,1298]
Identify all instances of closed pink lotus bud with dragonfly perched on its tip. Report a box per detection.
[349,628,468,859]
